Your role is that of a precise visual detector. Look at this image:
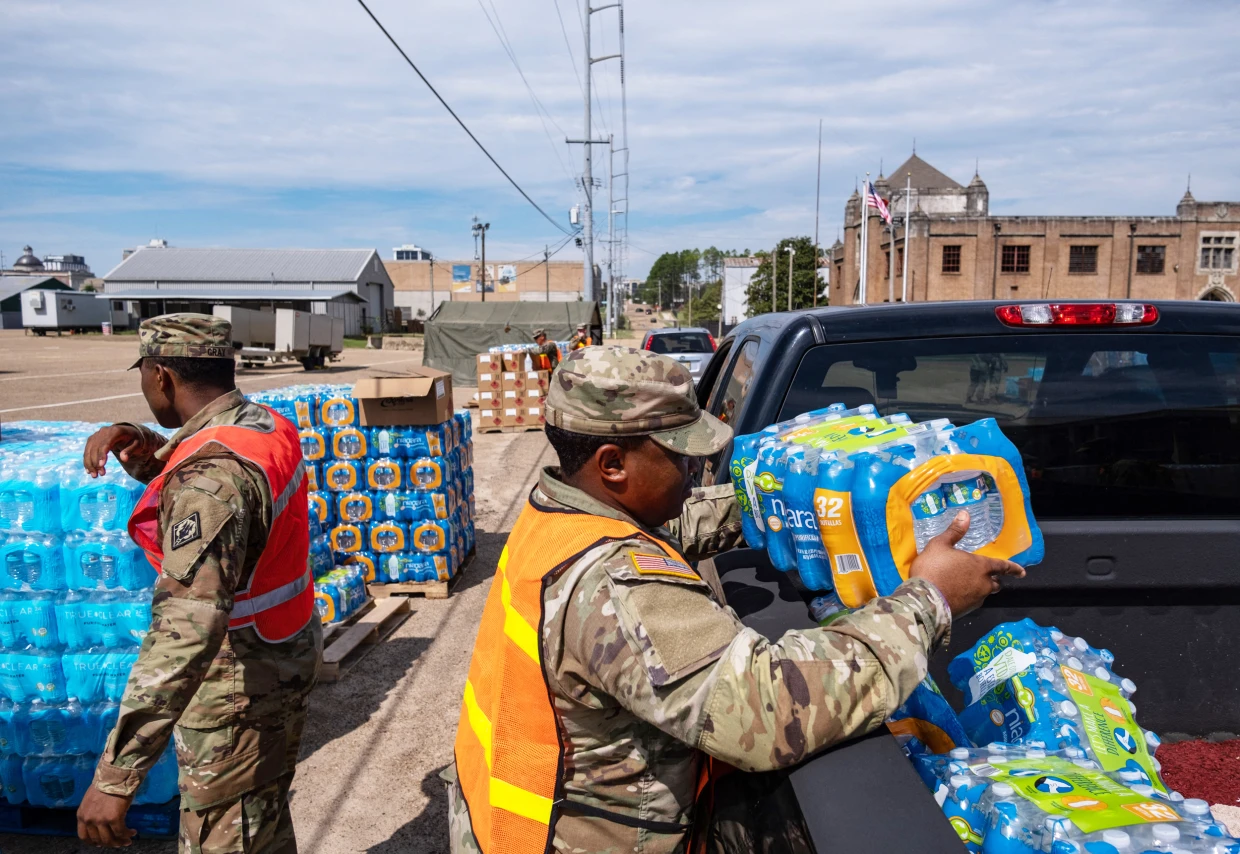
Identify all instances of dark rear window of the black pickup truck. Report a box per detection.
[780,333,1240,518]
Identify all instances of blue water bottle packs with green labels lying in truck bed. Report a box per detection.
[911,620,1240,854]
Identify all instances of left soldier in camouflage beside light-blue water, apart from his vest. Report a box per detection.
[78,314,322,854]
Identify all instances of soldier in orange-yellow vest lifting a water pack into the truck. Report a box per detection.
[446,347,1023,854]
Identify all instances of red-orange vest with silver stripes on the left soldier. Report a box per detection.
[129,407,314,643]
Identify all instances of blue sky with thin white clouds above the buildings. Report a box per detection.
[0,0,1240,275]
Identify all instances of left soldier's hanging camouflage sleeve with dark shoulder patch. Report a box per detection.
[94,460,257,797]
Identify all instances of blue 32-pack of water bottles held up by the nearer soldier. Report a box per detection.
[730,404,1043,752]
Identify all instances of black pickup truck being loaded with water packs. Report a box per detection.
[698,301,1240,854]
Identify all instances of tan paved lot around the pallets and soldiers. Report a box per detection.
[0,332,556,854]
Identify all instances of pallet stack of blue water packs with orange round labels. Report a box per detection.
[252,385,474,622]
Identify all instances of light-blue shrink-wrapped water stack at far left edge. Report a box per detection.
[0,421,177,807]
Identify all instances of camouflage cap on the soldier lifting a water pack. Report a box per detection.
[544,347,732,456]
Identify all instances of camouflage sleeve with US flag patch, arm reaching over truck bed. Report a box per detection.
[557,543,951,771]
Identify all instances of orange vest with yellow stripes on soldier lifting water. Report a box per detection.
[455,500,708,854]
